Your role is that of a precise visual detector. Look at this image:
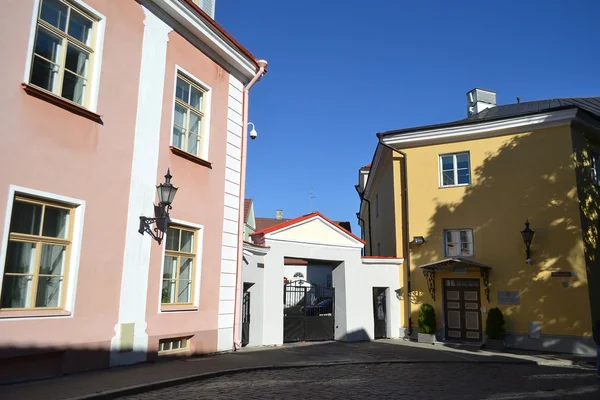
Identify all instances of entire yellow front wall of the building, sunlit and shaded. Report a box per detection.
[396,126,591,335]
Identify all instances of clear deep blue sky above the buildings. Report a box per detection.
[215,0,600,234]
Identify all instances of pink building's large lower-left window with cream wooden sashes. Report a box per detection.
[0,197,73,310]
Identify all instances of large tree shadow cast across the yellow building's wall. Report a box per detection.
[412,128,600,336]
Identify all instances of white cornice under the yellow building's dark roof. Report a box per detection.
[383,109,577,148]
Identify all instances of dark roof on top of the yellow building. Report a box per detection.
[378,97,600,136]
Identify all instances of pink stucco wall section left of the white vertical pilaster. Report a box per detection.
[0,0,144,376]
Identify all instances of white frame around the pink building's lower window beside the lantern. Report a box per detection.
[158,218,204,314]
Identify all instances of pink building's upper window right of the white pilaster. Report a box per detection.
[172,73,207,158]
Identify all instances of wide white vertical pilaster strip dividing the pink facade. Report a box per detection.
[110,7,172,366]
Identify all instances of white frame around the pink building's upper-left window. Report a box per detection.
[23,0,106,112]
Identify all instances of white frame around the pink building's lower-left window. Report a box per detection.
[0,185,86,323]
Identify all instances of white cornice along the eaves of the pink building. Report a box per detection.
[148,0,258,82]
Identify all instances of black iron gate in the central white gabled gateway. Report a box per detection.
[283,281,335,343]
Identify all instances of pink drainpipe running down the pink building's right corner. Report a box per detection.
[233,60,268,351]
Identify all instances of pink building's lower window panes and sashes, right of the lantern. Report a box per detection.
[161,227,196,305]
